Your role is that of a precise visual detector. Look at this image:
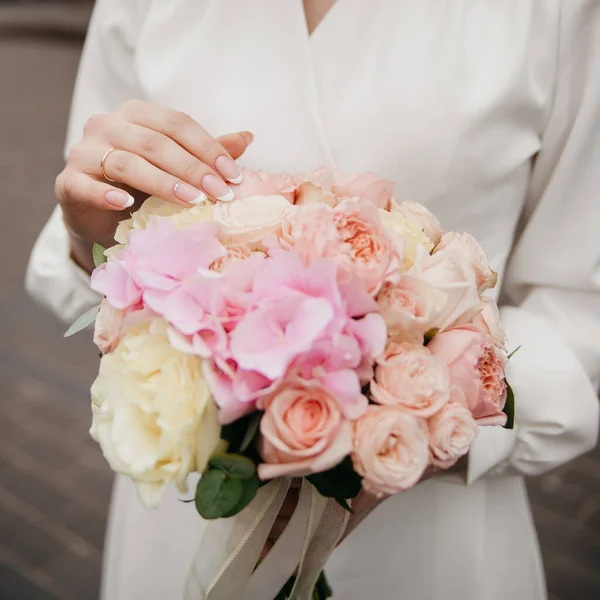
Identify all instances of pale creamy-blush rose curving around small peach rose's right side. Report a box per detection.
[408,251,481,331]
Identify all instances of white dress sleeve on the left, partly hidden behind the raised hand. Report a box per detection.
[26,0,147,321]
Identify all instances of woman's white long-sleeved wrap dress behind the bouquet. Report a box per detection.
[28,0,600,600]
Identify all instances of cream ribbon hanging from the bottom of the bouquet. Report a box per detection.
[184,478,350,600]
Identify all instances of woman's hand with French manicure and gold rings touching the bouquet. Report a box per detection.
[55,100,253,267]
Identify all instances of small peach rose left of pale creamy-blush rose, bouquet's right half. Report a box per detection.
[377,276,446,344]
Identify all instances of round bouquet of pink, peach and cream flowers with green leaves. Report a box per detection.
[67,169,513,600]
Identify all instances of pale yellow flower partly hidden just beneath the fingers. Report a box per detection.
[115,196,214,244]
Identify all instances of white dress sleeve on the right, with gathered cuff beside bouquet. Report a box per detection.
[467,0,600,483]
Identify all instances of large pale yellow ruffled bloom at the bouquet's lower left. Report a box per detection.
[90,318,223,506]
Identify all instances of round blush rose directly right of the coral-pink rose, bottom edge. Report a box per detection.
[352,405,429,498]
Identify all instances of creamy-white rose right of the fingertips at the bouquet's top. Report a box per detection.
[214,195,297,249]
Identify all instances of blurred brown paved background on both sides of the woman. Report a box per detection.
[0,0,600,600]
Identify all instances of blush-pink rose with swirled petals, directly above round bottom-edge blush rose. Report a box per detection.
[371,342,450,418]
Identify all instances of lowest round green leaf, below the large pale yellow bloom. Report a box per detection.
[195,469,244,519]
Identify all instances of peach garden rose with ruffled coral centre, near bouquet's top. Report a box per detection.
[331,200,398,294]
